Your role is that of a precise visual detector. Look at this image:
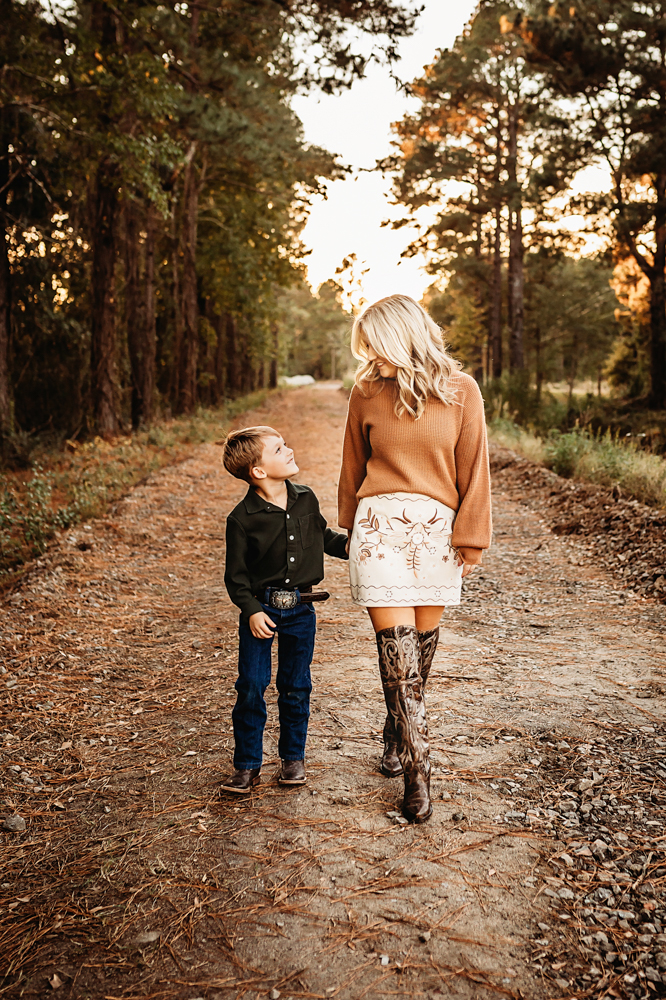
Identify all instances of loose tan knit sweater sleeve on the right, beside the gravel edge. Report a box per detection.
[451,378,492,562]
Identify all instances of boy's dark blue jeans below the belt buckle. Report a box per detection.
[231,604,317,770]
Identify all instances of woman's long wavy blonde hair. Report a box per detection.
[351,295,461,420]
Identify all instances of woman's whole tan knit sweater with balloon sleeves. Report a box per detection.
[338,372,492,563]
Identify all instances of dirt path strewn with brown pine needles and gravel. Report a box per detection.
[0,387,666,1000]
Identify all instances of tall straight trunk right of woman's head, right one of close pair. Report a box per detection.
[506,104,525,371]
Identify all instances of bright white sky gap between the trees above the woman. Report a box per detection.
[293,0,476,302]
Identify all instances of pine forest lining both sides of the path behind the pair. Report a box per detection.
[0,0,666,469]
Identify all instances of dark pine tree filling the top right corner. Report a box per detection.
[506,0,666,409]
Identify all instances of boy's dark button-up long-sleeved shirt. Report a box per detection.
[224,480,348,618]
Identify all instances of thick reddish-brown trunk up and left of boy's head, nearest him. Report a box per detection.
[178,143,199,413]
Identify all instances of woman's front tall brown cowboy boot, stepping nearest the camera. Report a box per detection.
[377,625,432,823]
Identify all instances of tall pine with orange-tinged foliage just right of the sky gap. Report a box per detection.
[384,0,563,377]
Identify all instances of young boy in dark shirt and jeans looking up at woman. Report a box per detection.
[222,427,348,795]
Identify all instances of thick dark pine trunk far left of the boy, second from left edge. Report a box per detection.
[90,161,119,437]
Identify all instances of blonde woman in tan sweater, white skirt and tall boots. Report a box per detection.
[338,295,491,823]
